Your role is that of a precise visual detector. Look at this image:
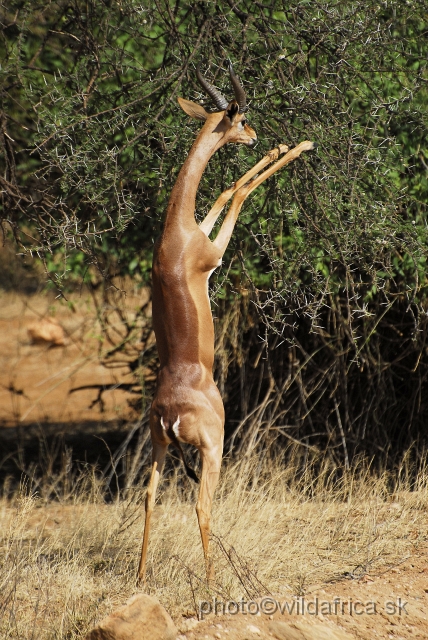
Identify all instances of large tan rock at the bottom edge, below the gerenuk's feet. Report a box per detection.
[85,593,177,640]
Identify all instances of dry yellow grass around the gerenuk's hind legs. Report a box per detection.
[0,456,428,640]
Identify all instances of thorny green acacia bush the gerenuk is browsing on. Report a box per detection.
[0,0,428,464]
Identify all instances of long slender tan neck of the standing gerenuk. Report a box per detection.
[164,113,224,231]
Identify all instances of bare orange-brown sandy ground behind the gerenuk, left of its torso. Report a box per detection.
[0,292,147,427]
